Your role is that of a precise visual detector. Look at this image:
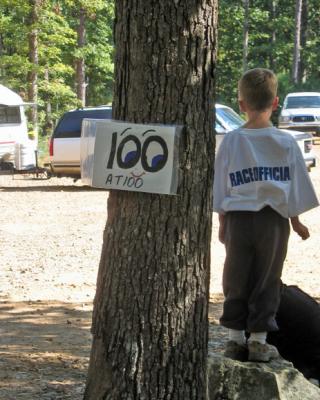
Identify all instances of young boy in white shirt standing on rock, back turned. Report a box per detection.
[214,68,319,362]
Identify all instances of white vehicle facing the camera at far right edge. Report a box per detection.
[279,92,320,136]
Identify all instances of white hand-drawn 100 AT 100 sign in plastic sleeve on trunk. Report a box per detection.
[81,120,182,194]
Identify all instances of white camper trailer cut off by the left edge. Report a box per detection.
[0,85,37,170]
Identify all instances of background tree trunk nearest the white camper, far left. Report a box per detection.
[28,0,40,136]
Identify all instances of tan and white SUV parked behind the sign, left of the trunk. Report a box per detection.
[49,106,112,179]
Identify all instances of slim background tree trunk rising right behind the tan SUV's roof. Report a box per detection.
[76,8,86,107]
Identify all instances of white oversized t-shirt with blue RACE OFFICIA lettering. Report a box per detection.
[213,127,319,218]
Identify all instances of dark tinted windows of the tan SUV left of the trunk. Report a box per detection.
[53,108,112,138]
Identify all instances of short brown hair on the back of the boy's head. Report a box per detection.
[238,68,278,111]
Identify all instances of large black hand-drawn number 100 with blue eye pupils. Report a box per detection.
[107,128,168,172]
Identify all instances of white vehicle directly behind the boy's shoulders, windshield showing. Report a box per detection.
[215,104,316,170]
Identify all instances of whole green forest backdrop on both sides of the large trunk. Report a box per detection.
[0,0,320,139]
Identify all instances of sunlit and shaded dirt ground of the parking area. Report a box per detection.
[0,145,320,400]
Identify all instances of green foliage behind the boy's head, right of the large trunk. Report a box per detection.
[217,0,320,109]
